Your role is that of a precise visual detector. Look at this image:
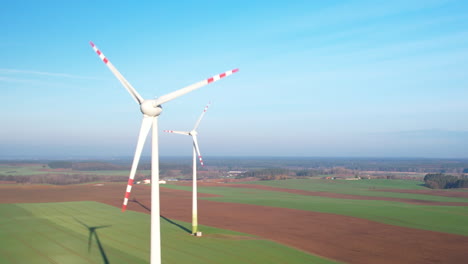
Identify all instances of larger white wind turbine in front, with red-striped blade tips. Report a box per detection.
[90,42,238,264]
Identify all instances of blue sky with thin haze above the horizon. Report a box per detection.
[0,0,468,158]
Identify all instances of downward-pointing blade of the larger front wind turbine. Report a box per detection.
[122,116,153,212]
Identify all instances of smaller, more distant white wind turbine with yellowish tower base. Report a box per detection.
[164,103,210,235]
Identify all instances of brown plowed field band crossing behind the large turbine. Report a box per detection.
[0,184,468,263]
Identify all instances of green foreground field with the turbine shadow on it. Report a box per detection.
[0,202,336,264]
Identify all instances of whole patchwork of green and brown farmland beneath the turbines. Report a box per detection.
[0,160,468,263]
